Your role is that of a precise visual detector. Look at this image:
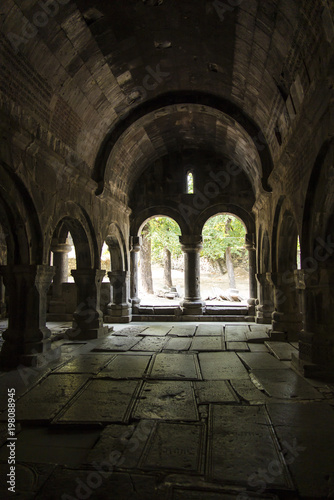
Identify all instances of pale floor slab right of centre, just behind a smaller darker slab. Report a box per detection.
[198,352,248,380]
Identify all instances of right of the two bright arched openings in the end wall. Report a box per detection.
[201,213,249,305]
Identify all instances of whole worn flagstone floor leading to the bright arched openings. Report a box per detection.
[0,323,334,500]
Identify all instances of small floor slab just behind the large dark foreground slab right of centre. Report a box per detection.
[194,380,239,404]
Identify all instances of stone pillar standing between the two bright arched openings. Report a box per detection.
[180,235,205,314]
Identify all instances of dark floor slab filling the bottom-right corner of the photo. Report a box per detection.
[267,402,334,499]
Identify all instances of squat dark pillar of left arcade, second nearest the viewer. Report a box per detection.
[67,269,108,340]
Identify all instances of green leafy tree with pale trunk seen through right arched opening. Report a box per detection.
[202,214,246,288]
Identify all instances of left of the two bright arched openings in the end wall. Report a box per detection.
[139,217,184,306]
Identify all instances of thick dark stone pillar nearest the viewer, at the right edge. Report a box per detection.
[292,266,334,381]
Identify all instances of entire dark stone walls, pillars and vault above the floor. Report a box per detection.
[0,0,334,376]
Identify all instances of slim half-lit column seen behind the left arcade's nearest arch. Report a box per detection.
[49,243,71,314]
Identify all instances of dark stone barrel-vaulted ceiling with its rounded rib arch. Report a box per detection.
[0,0,323,203]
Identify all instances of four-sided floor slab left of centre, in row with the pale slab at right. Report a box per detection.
[98,354,151,379]
